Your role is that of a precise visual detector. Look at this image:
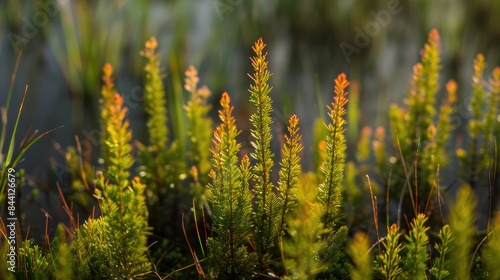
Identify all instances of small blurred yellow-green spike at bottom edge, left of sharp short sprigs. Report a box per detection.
[346,232,373,280]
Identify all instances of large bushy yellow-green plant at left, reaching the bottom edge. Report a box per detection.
[74,64,150,278]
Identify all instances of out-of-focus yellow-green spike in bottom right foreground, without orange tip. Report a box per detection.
[450,185,477,280]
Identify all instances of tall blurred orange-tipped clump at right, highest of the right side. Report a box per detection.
[382,29,456,219]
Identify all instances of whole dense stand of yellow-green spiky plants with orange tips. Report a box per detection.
[0,30,500,279]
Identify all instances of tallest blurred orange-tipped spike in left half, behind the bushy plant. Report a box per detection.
[135,37,188,246]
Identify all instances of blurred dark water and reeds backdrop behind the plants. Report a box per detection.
[0,0,500,238]
